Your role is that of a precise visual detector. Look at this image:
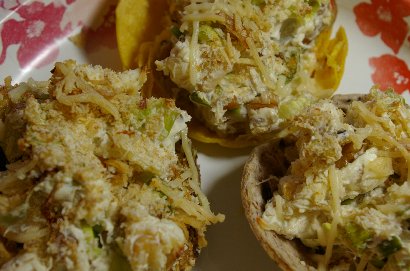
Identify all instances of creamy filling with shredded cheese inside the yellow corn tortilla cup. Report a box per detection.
[155,0,333,136]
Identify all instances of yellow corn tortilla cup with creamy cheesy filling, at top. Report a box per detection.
[117,0,347,147]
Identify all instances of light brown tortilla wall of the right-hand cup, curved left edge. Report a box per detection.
[241,142,315,271]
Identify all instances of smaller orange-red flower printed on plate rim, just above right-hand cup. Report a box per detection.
[369,55,410,94]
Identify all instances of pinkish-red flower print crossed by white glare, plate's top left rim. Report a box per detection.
[0,1,71,68]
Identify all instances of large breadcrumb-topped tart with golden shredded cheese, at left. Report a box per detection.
[0,61,223,270]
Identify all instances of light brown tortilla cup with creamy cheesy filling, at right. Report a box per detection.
[241,88,410,270]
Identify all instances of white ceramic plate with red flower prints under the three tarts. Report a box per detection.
[0,0,410,271]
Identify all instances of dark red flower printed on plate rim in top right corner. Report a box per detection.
[353,0,410,54]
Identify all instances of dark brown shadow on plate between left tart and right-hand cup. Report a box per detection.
[194,164,279,271]
